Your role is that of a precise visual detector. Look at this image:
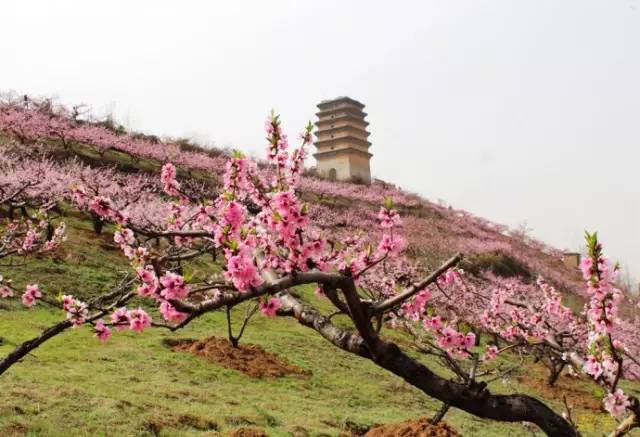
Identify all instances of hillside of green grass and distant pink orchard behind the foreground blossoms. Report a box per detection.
[0,97,640,436]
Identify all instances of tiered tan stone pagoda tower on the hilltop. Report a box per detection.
[313,97,373,184]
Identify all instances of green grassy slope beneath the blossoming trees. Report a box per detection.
[0,218,632,436]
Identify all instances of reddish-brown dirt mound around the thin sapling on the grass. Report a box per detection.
[166,337,311,378]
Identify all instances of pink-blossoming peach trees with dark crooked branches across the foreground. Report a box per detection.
[0,103,640,436]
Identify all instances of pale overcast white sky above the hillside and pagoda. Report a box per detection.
[0,0,640,282]
